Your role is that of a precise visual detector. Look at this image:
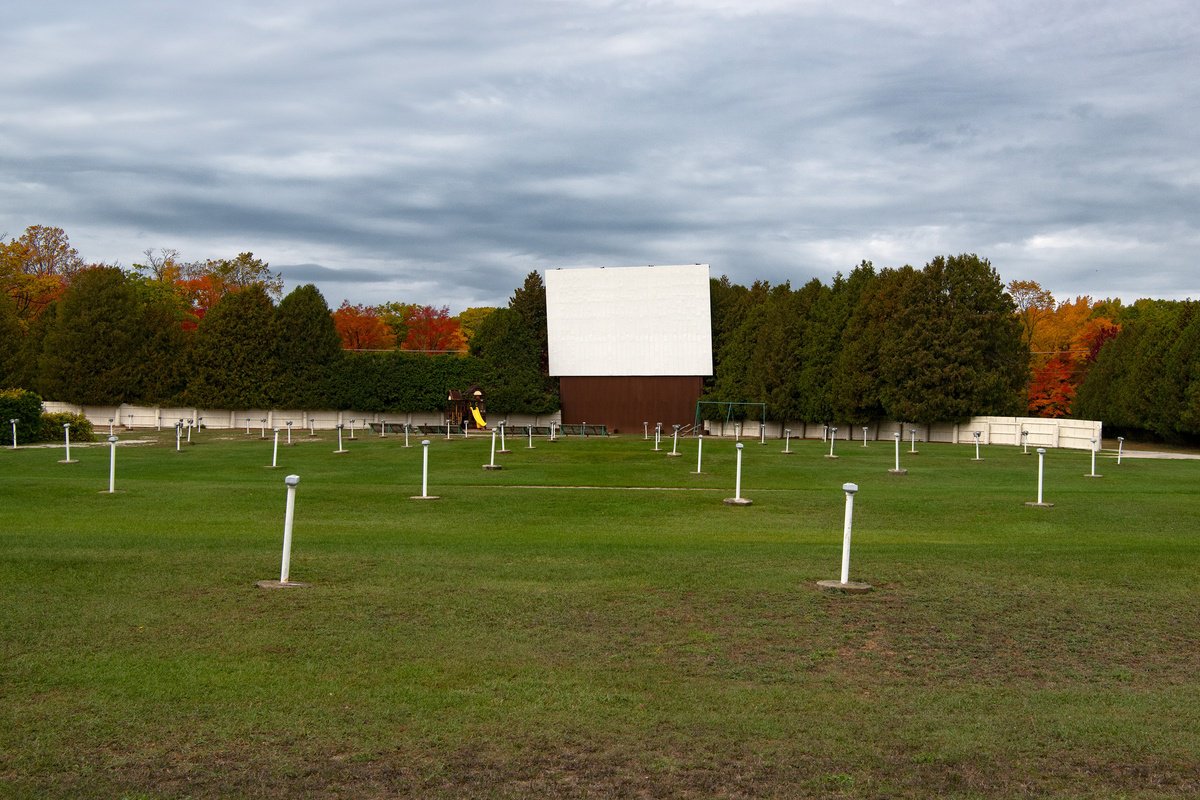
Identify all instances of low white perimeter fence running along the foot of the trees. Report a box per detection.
[42,402,1102,450]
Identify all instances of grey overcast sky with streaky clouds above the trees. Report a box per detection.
[0,0,1200,312]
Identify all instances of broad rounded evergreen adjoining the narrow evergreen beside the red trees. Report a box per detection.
[186,285,278,409]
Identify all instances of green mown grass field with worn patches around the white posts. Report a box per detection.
[0,431,1200,798]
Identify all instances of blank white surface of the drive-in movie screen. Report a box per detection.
[546,264,713,377]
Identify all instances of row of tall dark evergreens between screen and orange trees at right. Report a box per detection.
[704,254,1028,425]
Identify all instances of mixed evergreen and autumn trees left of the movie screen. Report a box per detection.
[0,227,558,414]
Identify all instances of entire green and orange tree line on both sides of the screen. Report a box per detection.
[0,225,1200,439]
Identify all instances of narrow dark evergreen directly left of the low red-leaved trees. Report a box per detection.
[274,283,342,409]
